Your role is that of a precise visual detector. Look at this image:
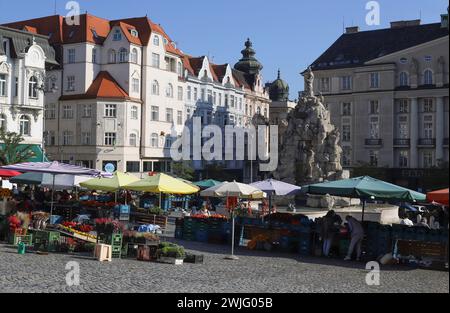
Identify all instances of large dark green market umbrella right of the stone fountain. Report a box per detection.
[302,176,426,201]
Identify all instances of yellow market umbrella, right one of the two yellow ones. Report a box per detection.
[124,173,200,195]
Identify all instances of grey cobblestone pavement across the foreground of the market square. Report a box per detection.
[0,241,449,293]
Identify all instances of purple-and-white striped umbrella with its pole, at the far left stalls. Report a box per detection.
[0,161,112,222]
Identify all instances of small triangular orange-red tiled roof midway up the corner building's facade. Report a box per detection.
[60,71,130,100]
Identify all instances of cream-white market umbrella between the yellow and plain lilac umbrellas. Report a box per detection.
[200,182,267,199]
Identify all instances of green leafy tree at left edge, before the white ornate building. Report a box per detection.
[0,130,35,166]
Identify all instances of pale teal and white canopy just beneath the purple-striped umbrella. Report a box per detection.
[9,172,90,189]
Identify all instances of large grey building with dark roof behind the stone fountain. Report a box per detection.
[312,15,449,188]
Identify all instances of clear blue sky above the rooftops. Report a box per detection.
[0,0,448,99]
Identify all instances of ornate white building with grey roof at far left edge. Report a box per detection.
[0,26,58,161]
